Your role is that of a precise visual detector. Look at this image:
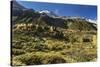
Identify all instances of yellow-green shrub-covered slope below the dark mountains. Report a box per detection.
[12,25,96,65]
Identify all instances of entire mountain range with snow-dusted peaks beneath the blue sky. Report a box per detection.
[12,1,97,31]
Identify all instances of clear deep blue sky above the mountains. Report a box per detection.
[18,1,97,20]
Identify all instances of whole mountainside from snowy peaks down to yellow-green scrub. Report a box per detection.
[11,2,97,66]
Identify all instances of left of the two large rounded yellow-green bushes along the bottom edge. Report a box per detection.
[14,53,42,65]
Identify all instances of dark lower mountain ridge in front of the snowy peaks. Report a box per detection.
[11,9,97,31]
